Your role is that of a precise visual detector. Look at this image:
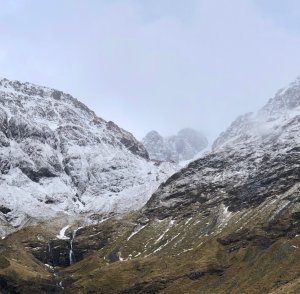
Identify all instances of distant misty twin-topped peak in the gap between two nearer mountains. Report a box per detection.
[142,128,208,163]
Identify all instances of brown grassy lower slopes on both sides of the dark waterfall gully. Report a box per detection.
[0,194,300,294]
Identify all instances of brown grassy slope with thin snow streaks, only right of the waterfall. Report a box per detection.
[62,196,300,293]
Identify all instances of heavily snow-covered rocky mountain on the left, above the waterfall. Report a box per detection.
[0,79,175,234]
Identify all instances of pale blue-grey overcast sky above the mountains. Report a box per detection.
[0,0,300,140]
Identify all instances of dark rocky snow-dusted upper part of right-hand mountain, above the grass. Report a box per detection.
[147,78,300,219]
